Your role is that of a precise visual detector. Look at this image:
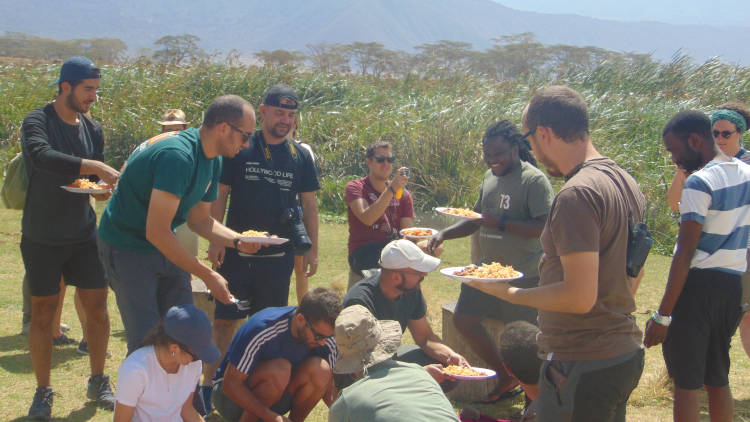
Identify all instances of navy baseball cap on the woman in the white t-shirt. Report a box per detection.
[163,304,220,363]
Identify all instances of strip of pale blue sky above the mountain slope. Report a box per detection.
[495,0,750,29]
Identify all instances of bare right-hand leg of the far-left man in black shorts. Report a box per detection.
[78,288,109,375]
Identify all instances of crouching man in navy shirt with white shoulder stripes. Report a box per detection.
[211,287,341,422]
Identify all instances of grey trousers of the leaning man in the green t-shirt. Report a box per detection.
[99,238,193,354]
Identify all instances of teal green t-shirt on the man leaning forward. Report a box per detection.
[99,128,221,253]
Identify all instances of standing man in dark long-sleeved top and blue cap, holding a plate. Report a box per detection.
[21,57,119,420]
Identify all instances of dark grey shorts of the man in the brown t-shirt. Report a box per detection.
[535,349,644,422]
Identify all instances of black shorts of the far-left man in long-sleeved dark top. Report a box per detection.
[21,236,107,296]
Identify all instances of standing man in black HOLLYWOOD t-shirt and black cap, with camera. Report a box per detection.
[203,84,320,403]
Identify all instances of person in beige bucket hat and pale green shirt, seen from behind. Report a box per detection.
[328,305,458,422]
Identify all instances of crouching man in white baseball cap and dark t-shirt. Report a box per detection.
[344,239,468,388]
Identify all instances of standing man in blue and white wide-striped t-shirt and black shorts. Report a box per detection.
[644,111,750,421]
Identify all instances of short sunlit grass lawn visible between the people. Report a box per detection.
[0,209,750,422]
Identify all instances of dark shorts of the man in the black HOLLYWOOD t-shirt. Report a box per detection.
[214,248,294,320]
